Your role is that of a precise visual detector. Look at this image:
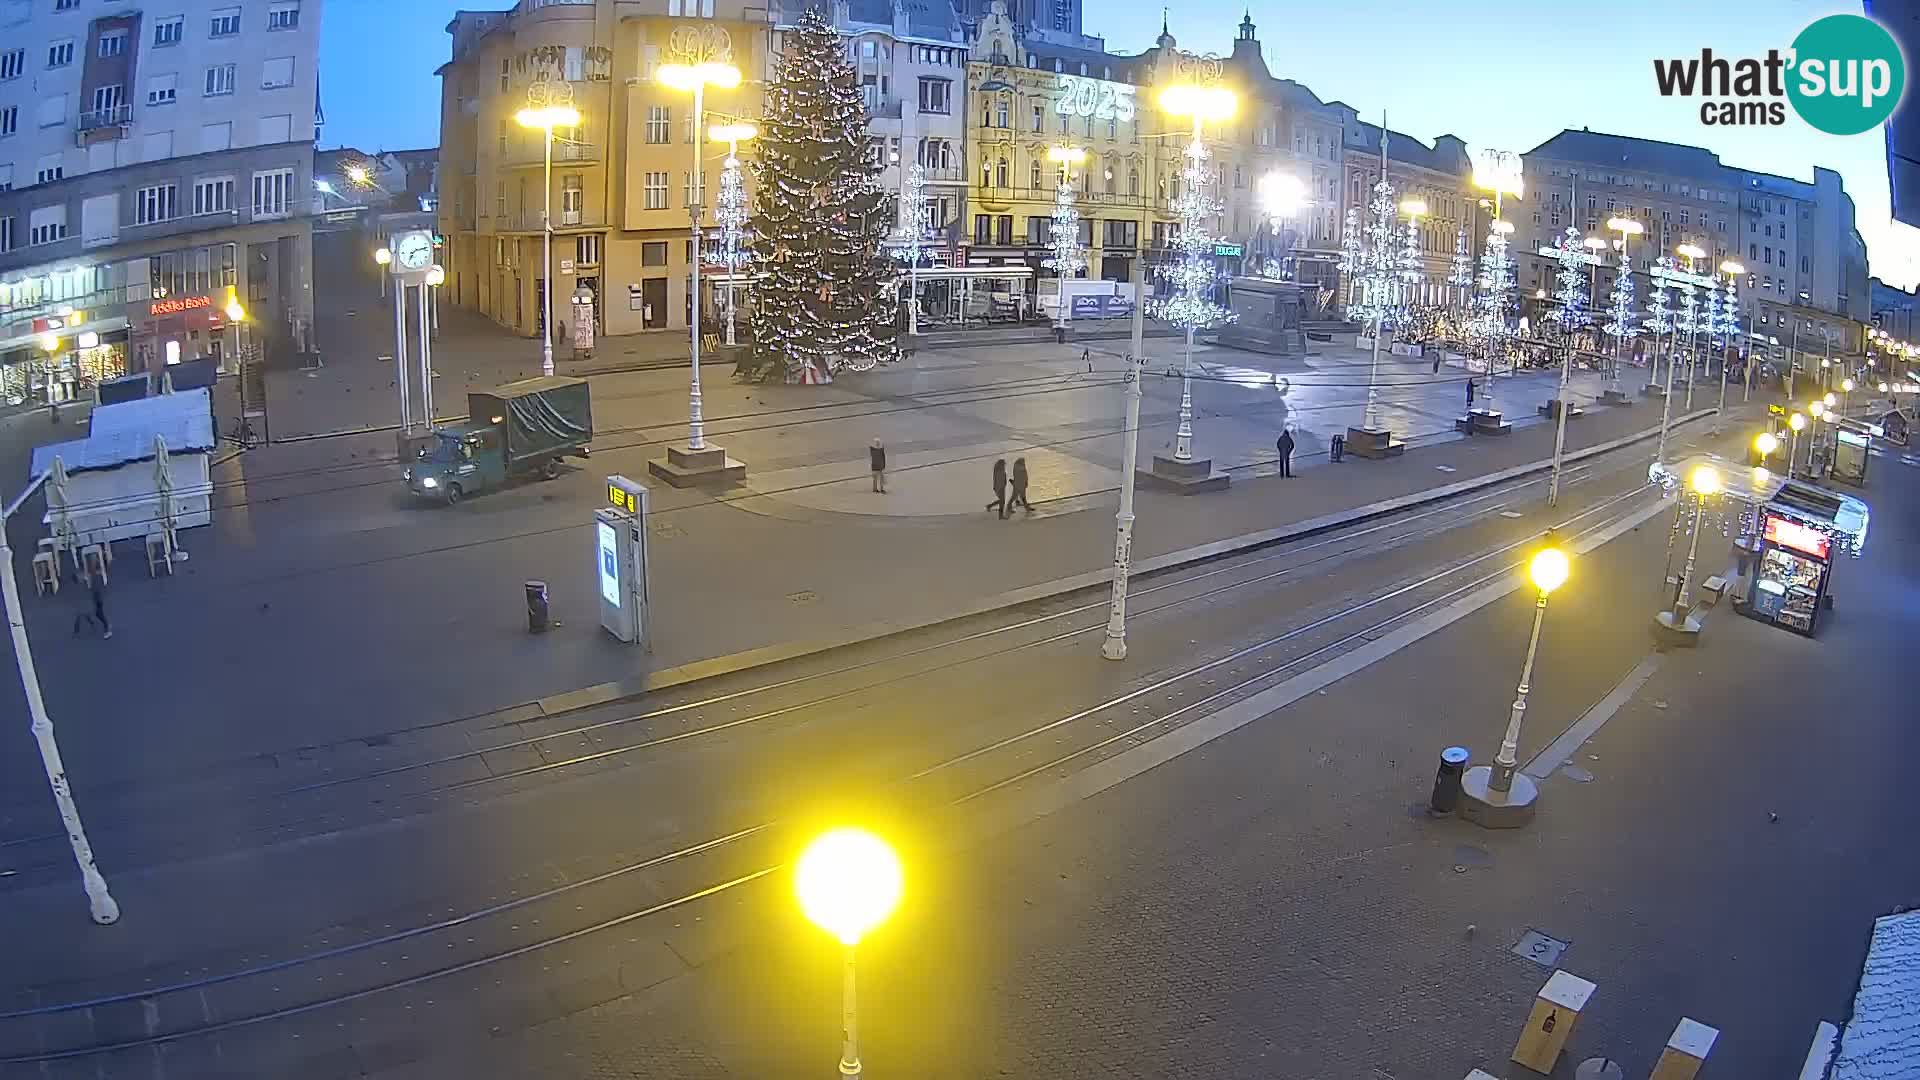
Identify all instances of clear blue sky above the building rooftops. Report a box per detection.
[321,0,1920,288]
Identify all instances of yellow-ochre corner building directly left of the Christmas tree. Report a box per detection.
[440,0,770,336]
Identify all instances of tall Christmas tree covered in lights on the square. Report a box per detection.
[753,12,899,382]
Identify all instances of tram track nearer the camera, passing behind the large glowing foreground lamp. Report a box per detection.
[0,474,1647,1065]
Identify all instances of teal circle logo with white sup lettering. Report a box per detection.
[1788,15,1907,135]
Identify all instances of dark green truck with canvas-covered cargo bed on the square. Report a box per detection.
[401,375,593,505]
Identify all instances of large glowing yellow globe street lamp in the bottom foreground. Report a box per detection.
[793,828,902,1076]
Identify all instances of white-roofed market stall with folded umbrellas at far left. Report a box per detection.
[29,388,215,552]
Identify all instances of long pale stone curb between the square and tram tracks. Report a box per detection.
[503,409,1715,723]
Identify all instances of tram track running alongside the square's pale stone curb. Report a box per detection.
[0,451,1630,871]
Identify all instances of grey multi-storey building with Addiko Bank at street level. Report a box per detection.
[0,0,321,404]
